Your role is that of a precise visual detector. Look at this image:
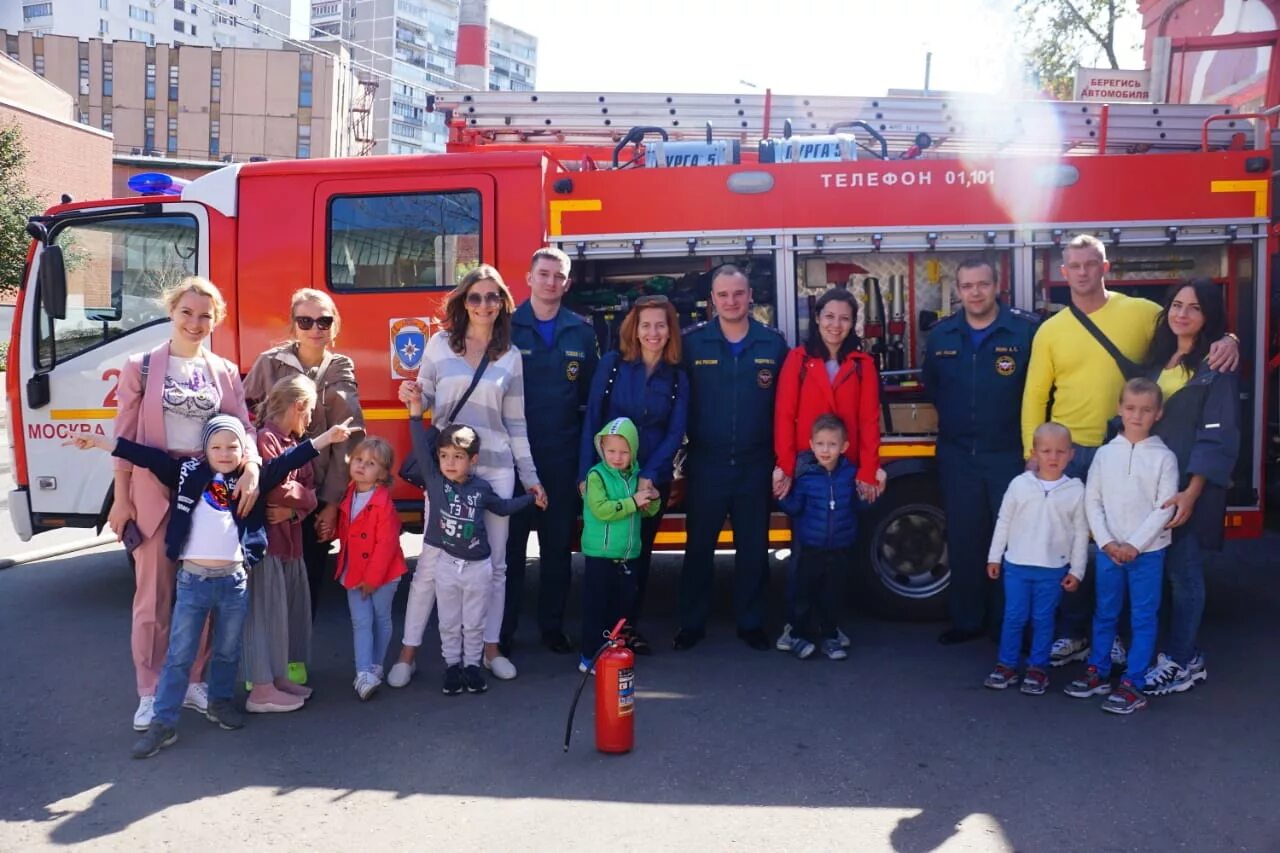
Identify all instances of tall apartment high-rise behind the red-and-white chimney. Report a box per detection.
[311,0,538,154]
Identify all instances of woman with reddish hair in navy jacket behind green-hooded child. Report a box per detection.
[577,296,689,654]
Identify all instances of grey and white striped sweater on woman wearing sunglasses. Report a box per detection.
[417,332,539,488]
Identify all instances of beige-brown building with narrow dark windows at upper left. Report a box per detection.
[0,31,365,161]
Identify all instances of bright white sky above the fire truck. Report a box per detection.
[489,0,1143,95]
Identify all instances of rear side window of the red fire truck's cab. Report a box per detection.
[329,190,480,291]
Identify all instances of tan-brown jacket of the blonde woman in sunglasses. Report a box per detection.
[244,342,365,503]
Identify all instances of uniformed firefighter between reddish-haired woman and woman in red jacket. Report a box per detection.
[675,264,787,651]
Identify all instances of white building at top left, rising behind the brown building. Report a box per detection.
[0,0,291,49]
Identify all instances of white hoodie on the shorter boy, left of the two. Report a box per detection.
[987,471,1089,580]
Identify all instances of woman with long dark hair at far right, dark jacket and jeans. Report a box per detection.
[1144,278,1240,695]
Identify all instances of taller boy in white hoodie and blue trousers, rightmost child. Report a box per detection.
[1066,379,1178,713]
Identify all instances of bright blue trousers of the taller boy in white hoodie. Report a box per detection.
[1089,548,1167,689]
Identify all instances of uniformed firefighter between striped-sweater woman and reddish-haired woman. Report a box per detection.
[499,248,599,654]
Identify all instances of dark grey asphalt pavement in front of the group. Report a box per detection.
[0,527,1280,852]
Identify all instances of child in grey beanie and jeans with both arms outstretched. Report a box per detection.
[65,415,352,758]
